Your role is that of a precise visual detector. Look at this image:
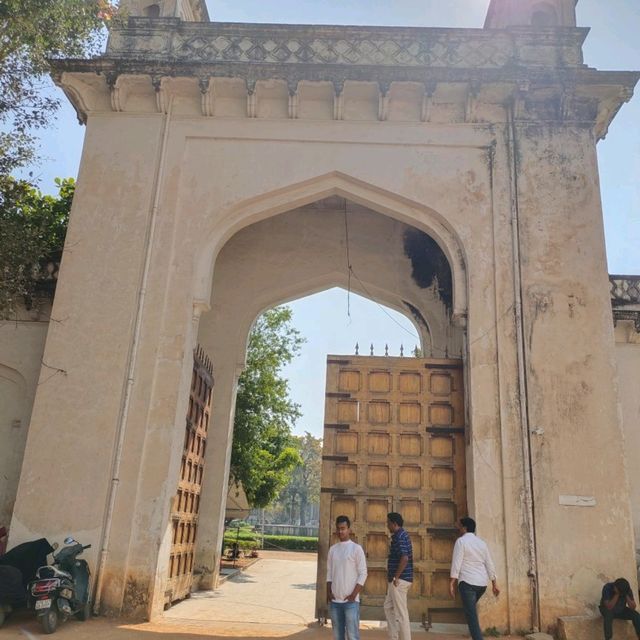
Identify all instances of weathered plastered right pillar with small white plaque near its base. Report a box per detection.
[515,124,636,629]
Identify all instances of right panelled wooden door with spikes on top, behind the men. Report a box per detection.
[316,356,467,622]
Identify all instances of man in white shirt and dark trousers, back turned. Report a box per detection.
[449,518,500,640]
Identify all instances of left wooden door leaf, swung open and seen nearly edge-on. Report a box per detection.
[165,347,213,604]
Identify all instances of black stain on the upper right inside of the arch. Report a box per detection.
[404,229,453,312]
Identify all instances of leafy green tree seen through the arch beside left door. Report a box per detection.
[231,307,304,507]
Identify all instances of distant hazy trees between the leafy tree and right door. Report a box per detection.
[278,431,322,526]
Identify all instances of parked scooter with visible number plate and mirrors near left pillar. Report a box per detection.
[29,538,91,633]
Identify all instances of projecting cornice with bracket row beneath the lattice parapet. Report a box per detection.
[52,56,640,138]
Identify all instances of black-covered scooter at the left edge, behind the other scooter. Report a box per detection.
[0,538,57,626]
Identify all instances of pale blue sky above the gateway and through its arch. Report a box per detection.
[22,0,640,435]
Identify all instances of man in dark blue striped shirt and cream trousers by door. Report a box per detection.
[384,513,413,640]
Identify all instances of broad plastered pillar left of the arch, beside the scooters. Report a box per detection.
[11,105,202,617]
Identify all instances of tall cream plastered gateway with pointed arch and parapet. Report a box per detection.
[6,0,638,630]
